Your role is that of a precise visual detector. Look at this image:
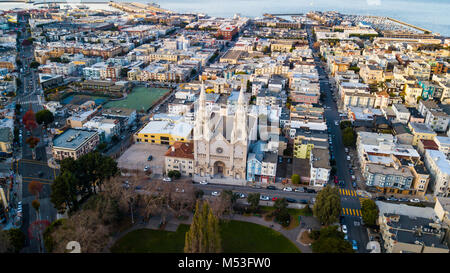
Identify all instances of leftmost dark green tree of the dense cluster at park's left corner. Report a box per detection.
[50,170,78,213]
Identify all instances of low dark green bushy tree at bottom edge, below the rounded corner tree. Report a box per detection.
[311,226,354,253]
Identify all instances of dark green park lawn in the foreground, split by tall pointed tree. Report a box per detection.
[111,221,300,253]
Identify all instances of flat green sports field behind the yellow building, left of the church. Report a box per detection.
[104,87,170,111]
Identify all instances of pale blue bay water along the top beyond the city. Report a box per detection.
[0,0,450,36]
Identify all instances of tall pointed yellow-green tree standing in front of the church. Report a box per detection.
[184,201,222,253]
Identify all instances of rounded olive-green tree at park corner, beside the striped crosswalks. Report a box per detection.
[313,186,341,225]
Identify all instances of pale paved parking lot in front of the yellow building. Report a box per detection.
[118,143,168,175]
